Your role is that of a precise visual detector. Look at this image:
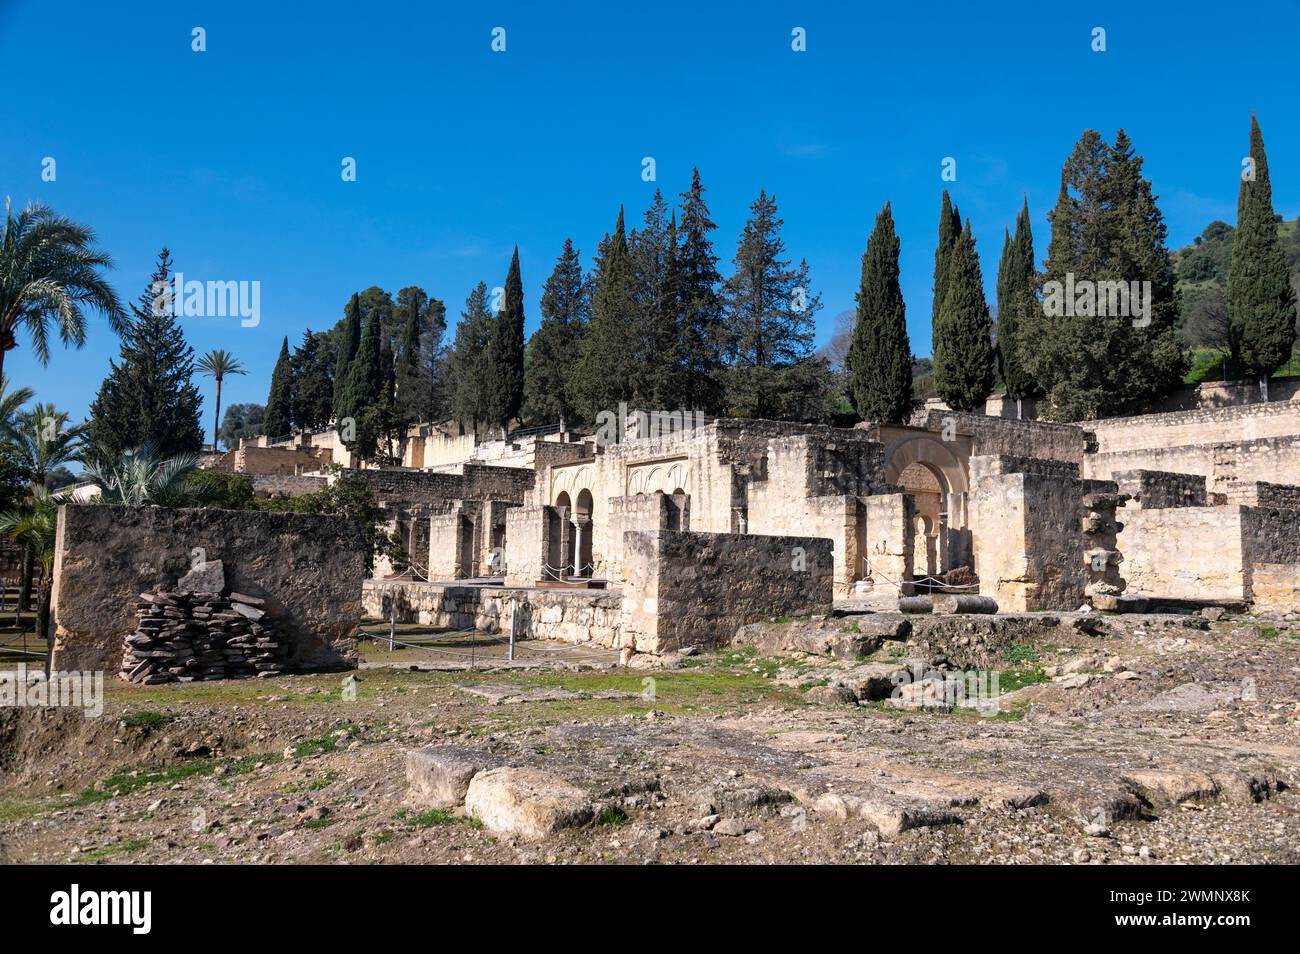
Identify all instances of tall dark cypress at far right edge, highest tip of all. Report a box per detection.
[1227,116,1296,400]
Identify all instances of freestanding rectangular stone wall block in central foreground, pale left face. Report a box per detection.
[623,530,833,654]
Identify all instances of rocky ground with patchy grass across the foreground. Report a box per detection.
[0,615,1300,864]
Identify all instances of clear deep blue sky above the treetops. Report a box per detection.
[0,0,1300,428]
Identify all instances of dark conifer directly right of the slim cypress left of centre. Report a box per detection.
[524,239,590,424]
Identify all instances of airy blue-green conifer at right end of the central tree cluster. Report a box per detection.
[723,191,829,420]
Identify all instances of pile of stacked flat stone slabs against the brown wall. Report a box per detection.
[121,593,287,685]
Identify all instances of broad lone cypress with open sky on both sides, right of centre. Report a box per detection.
[845,203,911,424]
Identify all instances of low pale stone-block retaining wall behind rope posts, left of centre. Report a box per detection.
[363,580,623,649]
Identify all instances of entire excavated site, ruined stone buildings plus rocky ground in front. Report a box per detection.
[0,399,1300,864]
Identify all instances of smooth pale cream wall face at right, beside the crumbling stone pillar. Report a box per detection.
[1119,507,1249,599]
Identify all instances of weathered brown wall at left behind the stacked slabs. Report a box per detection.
[51,504,365,669]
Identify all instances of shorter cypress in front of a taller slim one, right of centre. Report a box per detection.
[935,220,993,411]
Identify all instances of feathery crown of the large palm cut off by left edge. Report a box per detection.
[0,198,127,374]
